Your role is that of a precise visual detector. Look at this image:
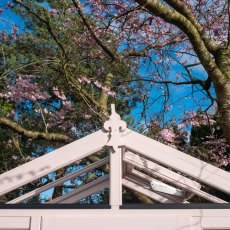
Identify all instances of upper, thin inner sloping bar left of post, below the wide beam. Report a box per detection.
[7,157,109,204]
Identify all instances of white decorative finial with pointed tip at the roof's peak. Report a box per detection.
[104,104,127,150]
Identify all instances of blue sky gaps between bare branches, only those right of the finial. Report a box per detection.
[132,56,215,129]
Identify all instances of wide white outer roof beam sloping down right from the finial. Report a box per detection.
[123,129,230,194]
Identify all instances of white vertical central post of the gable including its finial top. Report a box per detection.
[104,104,126,209]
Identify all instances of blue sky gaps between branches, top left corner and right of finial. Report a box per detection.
[0,0,215,129]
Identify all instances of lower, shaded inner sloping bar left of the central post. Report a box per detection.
[47,175,109,204]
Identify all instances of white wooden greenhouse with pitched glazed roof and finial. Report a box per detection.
[0,105,230,230]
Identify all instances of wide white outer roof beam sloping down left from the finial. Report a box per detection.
[0,130,109,196]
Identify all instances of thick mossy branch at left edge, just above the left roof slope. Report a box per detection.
[0,117,71,143]
